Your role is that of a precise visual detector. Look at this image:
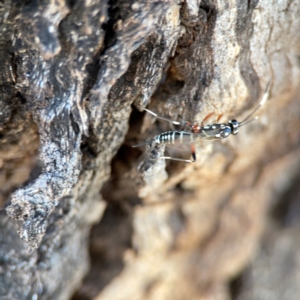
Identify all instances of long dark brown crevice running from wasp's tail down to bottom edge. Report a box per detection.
[72,107,144,300]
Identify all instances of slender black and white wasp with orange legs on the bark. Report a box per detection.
[132,82,270,162]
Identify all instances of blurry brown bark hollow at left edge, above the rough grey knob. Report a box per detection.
[0,92,40,207]
